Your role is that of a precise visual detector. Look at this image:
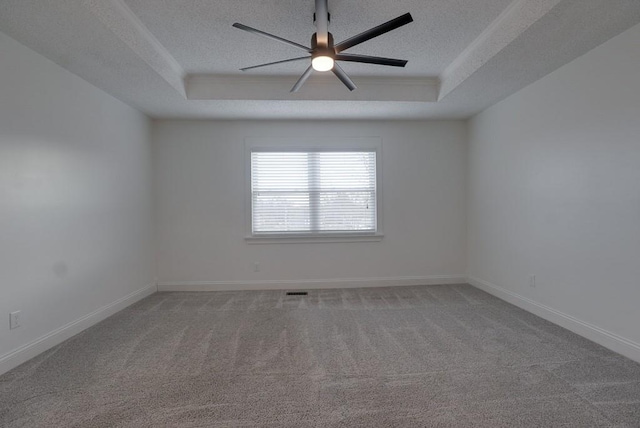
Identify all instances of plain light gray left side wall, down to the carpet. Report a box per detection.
[0,33,154,372]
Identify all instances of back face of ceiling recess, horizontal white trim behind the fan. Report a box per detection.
[185,74,440,102]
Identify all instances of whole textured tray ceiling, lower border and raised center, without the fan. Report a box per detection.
[0,0,640,119]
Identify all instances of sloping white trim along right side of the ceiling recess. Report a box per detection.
[438,0,561,100]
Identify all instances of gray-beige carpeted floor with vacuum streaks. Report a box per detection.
[0,285,640,428]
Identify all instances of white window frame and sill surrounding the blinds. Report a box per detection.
[244,137,384,244]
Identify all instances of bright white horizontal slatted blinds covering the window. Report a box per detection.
[251,150,377,235]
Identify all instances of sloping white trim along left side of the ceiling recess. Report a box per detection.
[83,0,186,97]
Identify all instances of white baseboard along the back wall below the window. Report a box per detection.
[158,275,467,291]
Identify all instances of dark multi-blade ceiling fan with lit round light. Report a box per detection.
[233,0,413,92]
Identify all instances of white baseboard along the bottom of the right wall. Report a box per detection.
[468,277,640,362]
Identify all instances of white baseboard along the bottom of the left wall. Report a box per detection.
[0,284,157,375]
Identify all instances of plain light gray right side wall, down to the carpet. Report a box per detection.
[468,22,640,360]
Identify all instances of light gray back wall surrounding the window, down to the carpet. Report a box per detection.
[153,120,467,289]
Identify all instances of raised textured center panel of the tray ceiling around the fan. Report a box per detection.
[125,0,512,76]
